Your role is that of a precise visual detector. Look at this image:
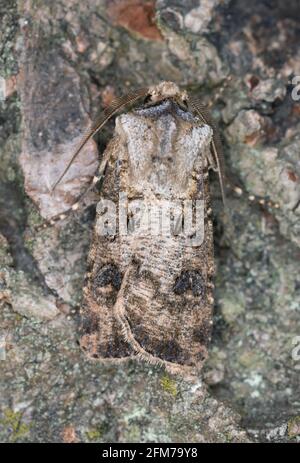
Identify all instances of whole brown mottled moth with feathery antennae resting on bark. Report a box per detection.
[54,82,225,374]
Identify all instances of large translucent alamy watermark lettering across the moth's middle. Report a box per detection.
[96,193,204,246]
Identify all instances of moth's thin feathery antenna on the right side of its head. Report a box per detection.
[189,98,226,205]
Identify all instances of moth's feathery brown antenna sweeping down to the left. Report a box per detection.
[52,88,149,191]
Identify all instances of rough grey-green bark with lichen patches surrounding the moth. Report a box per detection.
[0,0,300,442]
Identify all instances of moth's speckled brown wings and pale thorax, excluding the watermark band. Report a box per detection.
[80,98,214,373]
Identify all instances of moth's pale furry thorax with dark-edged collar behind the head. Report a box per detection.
[116,99,212,198]
